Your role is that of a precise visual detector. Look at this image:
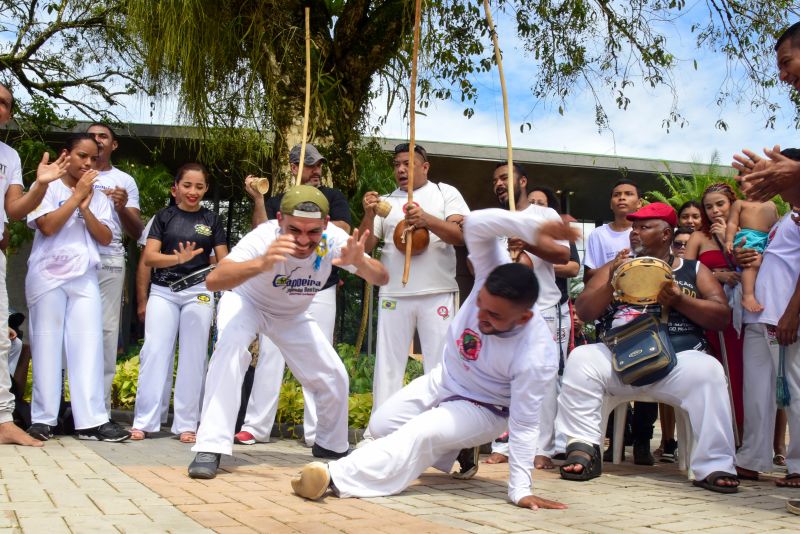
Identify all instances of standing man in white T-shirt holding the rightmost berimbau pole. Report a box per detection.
[482,163,569,469]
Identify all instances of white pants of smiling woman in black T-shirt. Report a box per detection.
[133,283,214,434]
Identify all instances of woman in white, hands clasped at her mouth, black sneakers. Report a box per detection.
[25,133,130,441]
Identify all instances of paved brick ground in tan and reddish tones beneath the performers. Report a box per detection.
[0,434,800,534]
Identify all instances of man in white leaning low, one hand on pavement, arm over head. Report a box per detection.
[292,209,569,509]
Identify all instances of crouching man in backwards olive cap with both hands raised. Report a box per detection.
[189,185,389,479]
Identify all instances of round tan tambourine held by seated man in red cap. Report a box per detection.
[611,256,674,304]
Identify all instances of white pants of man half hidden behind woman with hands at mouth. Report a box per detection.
[97,254,125,415]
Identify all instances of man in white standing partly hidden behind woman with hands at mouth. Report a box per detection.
[86,122,144,414]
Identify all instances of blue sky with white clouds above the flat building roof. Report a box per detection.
[124,13,800,168]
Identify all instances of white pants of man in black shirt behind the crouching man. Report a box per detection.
[242,285,336,445]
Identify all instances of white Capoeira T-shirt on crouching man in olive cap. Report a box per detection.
[223,221,357,317]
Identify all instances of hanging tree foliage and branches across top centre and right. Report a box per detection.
[127,0,800,197]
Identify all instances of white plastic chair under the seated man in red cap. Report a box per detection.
[600,395,694,480]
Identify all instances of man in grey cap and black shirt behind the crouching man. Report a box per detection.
[234,144,351,447]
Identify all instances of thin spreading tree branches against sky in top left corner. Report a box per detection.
[0,0,143,122]
